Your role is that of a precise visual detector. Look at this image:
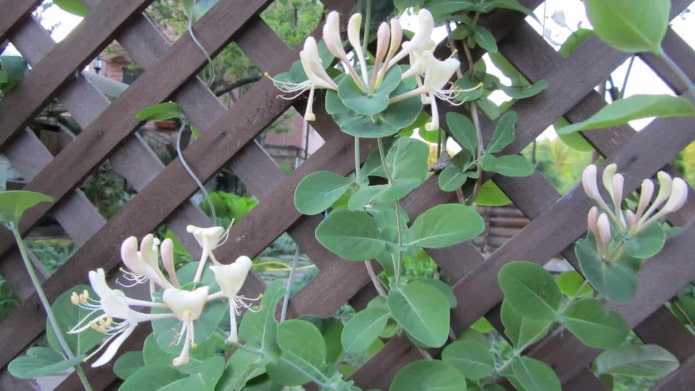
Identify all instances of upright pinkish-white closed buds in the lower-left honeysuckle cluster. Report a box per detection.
[121,234,172,290]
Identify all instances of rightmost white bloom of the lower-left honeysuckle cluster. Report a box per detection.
[210,256,253,343]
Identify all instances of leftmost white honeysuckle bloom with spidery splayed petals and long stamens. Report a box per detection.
[68,269,174,368]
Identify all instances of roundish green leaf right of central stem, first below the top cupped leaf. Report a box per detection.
[385,137,430,184]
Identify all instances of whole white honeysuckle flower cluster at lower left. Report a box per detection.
[69,225,252,367]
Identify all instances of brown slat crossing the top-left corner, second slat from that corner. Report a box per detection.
[0,0,152,146]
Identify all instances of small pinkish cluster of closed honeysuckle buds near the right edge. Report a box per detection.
[582,164,688,259]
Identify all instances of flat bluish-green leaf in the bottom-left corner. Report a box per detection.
[7,346,83,379]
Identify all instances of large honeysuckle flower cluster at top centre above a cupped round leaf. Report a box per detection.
[273,8,464,130]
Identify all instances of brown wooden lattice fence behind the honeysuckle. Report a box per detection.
[0,0,695,390]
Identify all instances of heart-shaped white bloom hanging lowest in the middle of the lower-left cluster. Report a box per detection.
[162,286,209,366]
